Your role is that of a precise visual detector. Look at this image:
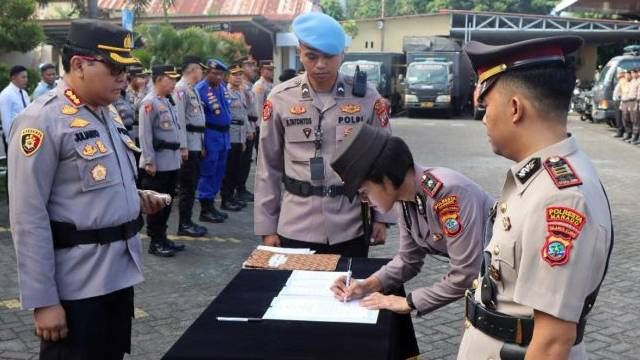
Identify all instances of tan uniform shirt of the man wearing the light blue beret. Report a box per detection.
[254,74,395,245]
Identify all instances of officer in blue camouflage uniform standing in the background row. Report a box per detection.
[196,59,231,223]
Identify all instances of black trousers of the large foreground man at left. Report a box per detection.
[40,287,134,360]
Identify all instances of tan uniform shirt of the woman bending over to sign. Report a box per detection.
[373,165,494,315]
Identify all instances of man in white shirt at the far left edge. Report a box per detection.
[0,65,30,154]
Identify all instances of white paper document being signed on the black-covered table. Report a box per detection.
[262,270,379,324]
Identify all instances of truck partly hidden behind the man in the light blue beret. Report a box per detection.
[340,52,405,112]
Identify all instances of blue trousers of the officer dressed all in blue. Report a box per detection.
[198,129,229,200]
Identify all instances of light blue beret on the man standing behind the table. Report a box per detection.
[293,12,345,55]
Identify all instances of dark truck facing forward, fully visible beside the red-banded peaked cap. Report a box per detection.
[403,36,475,116]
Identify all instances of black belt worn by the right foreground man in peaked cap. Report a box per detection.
[464,290,586,346]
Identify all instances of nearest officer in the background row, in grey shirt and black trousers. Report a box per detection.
[138,65,185,257]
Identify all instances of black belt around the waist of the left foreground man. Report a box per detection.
[51,215,144,250]
